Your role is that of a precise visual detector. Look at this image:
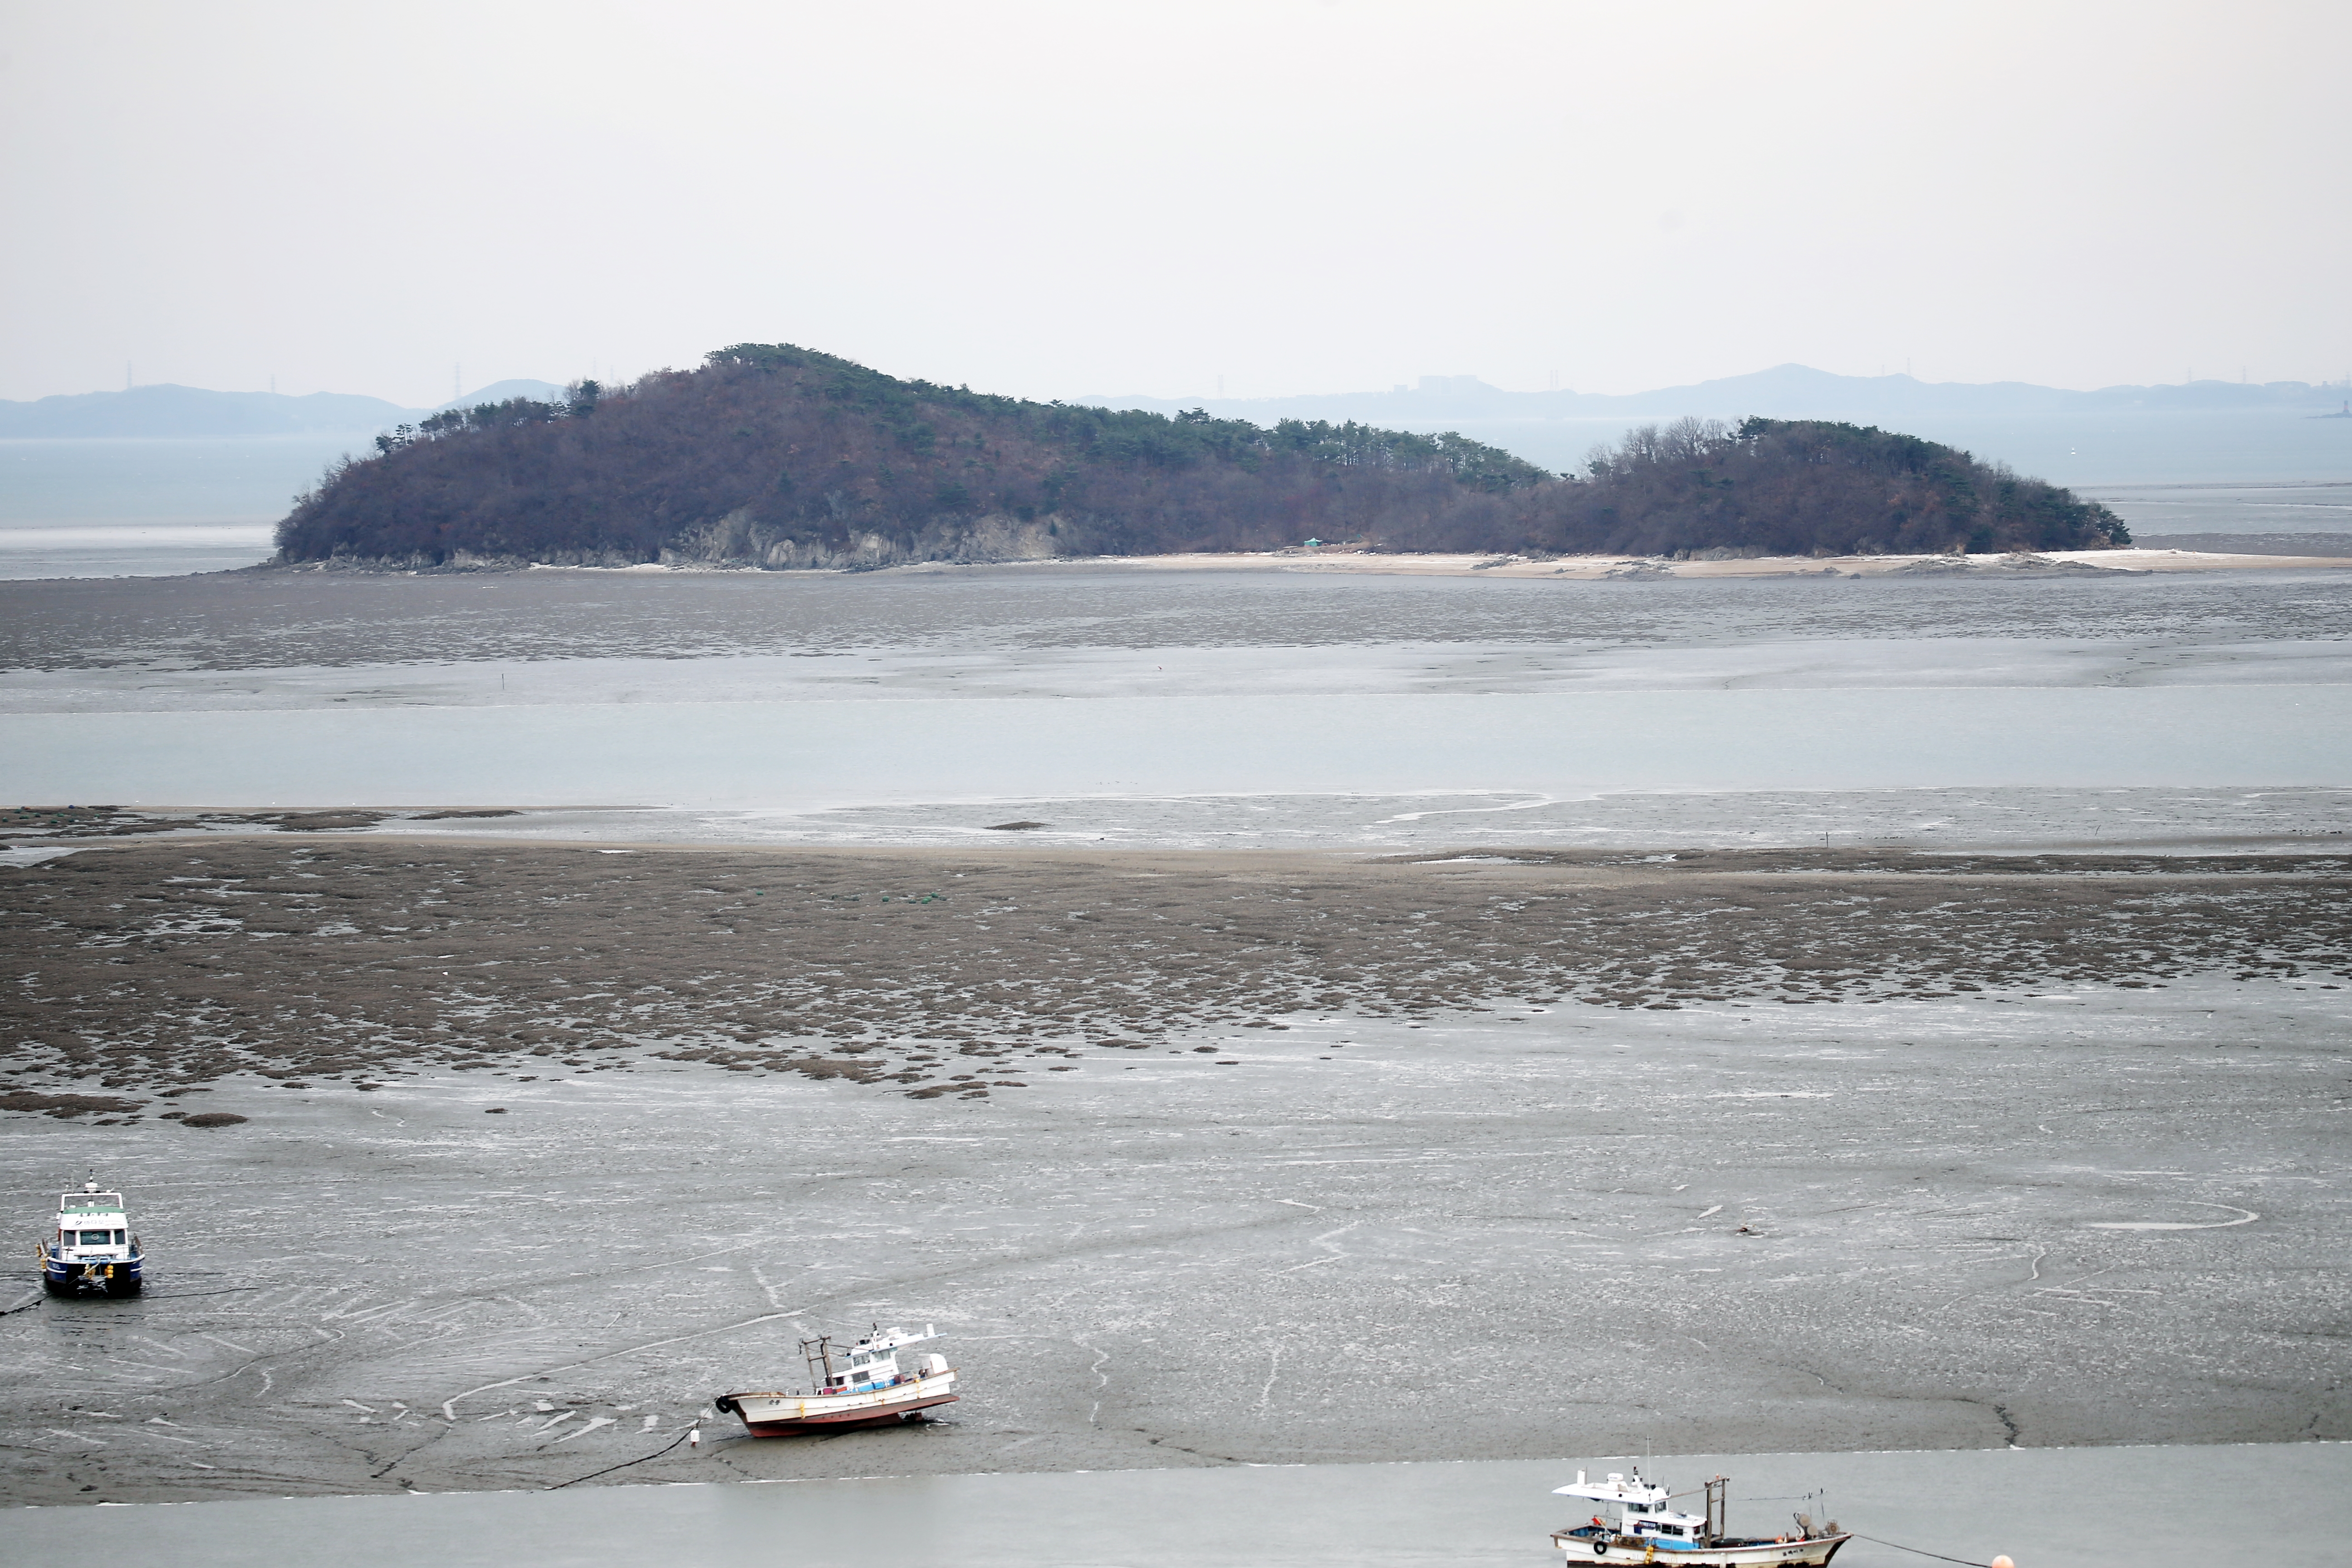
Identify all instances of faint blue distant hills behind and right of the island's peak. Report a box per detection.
[1073,364,2347,423]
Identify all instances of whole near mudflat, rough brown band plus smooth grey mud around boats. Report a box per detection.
[0,834,2352,1502]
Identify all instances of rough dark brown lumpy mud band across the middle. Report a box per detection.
[0,837,2352,1096]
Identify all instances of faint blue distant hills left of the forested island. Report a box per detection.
[0,381,562,437]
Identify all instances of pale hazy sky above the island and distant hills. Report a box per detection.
[0,0,2352,404]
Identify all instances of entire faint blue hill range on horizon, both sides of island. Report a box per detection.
[0,364,2347,437]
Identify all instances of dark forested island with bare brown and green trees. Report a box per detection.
[278,343,2131,569]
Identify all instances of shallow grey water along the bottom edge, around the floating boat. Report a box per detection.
[7,1443,2352,1568]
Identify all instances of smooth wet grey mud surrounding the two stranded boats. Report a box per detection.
[5,980,2352,1502]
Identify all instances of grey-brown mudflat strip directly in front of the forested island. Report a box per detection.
[0,557,2352,677]
